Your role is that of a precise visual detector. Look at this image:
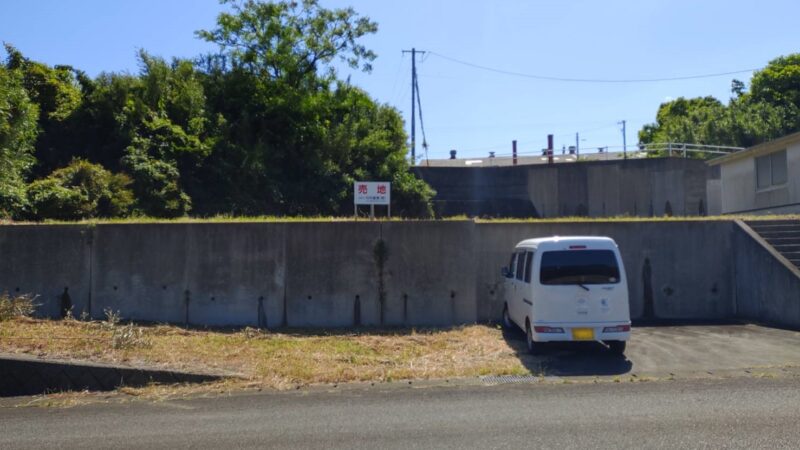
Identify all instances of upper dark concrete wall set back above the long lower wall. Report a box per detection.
[413,158,707,217]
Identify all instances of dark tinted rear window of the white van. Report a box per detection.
[539,250,619,285]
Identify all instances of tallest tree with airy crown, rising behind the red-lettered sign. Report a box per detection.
[192,0,431,216]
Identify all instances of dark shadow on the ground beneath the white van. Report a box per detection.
[503,329,633,376]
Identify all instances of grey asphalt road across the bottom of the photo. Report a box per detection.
[0,377,800,449]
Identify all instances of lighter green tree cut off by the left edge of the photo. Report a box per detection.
[0,66,39,217]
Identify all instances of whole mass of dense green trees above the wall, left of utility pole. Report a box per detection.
[0,0,433,220]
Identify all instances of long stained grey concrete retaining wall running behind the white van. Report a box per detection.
[0,221,800,327]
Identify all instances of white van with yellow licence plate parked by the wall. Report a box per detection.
[502,236,631,355]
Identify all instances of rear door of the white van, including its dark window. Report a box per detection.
[534,246,630,322]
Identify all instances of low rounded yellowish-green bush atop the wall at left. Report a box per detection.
[27,159,134,220]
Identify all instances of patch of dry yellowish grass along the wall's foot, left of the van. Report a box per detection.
[0,318,530,389]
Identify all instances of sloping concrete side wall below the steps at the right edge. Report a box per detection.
[733,221,800,328]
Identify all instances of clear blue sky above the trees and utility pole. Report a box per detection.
[0,0,800,158]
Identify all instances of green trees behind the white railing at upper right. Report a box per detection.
[639,54,800,147]
